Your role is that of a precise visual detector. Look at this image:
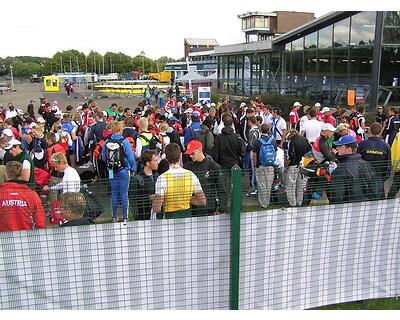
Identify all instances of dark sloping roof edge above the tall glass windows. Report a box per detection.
[272,11,360,45]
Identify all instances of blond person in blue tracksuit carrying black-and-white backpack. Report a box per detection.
[102,121,136,223]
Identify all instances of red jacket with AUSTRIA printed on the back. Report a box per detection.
[0,182,45,231]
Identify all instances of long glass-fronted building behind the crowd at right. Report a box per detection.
[214,11,400,107]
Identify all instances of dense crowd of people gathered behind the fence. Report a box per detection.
[0,91,400,231]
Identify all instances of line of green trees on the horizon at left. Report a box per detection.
[0,50,185,78]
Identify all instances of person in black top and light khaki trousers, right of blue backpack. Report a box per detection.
[285,129,311,207]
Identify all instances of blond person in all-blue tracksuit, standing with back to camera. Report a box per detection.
[102,121,136,223]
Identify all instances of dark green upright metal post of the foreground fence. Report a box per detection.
[229,165,242,310]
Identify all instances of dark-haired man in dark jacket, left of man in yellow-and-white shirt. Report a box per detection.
[129,150,158,220]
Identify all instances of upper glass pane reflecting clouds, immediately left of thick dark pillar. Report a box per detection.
[350,11,376,46]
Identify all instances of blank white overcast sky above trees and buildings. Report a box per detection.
[0,0,396,59]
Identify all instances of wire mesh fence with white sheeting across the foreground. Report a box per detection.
[0,162,400,309]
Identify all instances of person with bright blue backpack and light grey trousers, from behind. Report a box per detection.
[253,123,278,208]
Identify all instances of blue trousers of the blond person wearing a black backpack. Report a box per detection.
[110,169,129,220]
